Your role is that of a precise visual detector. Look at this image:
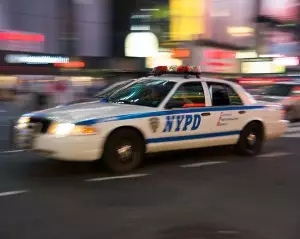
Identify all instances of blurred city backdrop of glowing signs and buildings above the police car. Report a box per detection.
[0,0,300,111]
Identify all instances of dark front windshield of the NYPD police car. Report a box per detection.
[109,79,175,107]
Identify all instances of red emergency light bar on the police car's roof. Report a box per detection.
[152,66,201,78]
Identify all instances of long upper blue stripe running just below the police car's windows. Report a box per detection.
[76,105,265,125]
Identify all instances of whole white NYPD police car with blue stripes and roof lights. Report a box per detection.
[15,66,287,173]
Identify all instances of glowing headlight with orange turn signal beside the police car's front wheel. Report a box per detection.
[48,123,97,136]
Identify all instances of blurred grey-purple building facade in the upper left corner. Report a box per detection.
[0,0,112,56]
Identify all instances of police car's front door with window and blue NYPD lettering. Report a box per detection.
[150,81,211,151]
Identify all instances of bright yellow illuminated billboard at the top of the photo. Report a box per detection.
[170,0,205,41]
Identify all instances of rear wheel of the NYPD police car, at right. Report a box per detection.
[236,122,264,156]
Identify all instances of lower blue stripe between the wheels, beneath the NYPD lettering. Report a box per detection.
[146,131,240,144]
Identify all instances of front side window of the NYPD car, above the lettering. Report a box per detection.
[166,82,205,109]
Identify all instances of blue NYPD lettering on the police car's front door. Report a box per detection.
[163,114,201,133]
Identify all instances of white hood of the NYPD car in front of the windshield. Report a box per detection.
[30,100,155,123]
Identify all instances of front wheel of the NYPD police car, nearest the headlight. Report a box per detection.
[103,129,145,173]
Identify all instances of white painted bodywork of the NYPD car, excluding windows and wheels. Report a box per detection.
[16,76,287,161]
